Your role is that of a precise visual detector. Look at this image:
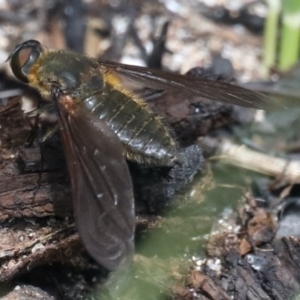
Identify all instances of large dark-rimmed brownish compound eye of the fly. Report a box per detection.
[7,40,44,83]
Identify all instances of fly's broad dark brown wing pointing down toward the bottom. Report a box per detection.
[56,96,135,271]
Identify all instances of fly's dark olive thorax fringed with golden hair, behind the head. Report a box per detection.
[28,51,104,98]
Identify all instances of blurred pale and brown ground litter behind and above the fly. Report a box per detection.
[0,0,276,80]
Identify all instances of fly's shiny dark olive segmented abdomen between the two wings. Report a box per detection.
[84,89,176,165]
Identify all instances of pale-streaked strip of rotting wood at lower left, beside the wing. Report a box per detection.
[0,222,82,282]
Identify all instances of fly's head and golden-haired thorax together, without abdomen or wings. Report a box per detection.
[8,40,104,99]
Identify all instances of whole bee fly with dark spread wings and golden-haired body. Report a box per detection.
[9,40,278,271]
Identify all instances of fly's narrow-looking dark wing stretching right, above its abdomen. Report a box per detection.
[100,61,285,110]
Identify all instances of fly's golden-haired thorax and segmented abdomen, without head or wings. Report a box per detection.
[24,51,176,165]
